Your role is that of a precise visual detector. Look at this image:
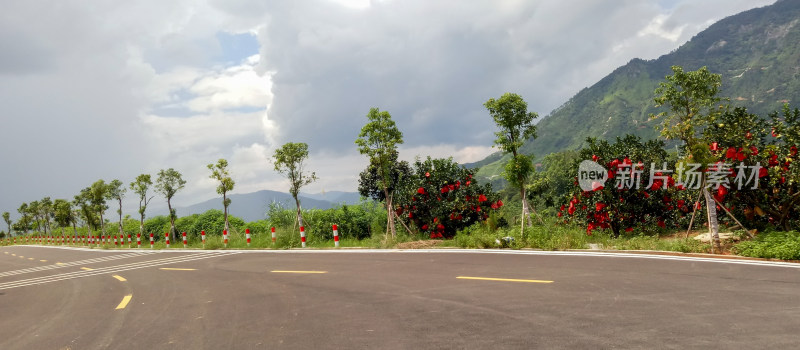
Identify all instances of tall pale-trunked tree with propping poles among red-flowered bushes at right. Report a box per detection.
[651,66,725,252]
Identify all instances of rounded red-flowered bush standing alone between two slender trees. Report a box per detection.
[394,157,503,238]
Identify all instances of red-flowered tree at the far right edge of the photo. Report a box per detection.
[704,106,800,231]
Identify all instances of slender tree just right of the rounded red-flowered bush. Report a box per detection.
[483,92,539,232]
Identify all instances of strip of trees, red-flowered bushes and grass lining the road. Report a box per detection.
[0,67,800,259]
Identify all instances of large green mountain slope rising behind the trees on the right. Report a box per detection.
[471,0,800,183]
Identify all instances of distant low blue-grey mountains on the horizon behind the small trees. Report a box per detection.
[148,190,361,222]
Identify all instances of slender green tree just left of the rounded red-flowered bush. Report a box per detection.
[356,108,403,237]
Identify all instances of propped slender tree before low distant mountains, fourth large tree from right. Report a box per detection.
[272,142,317,234]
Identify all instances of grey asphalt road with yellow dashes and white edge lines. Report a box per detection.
[0,246,800,349]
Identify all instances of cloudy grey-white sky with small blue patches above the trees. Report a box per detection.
[0,0,774,214]
